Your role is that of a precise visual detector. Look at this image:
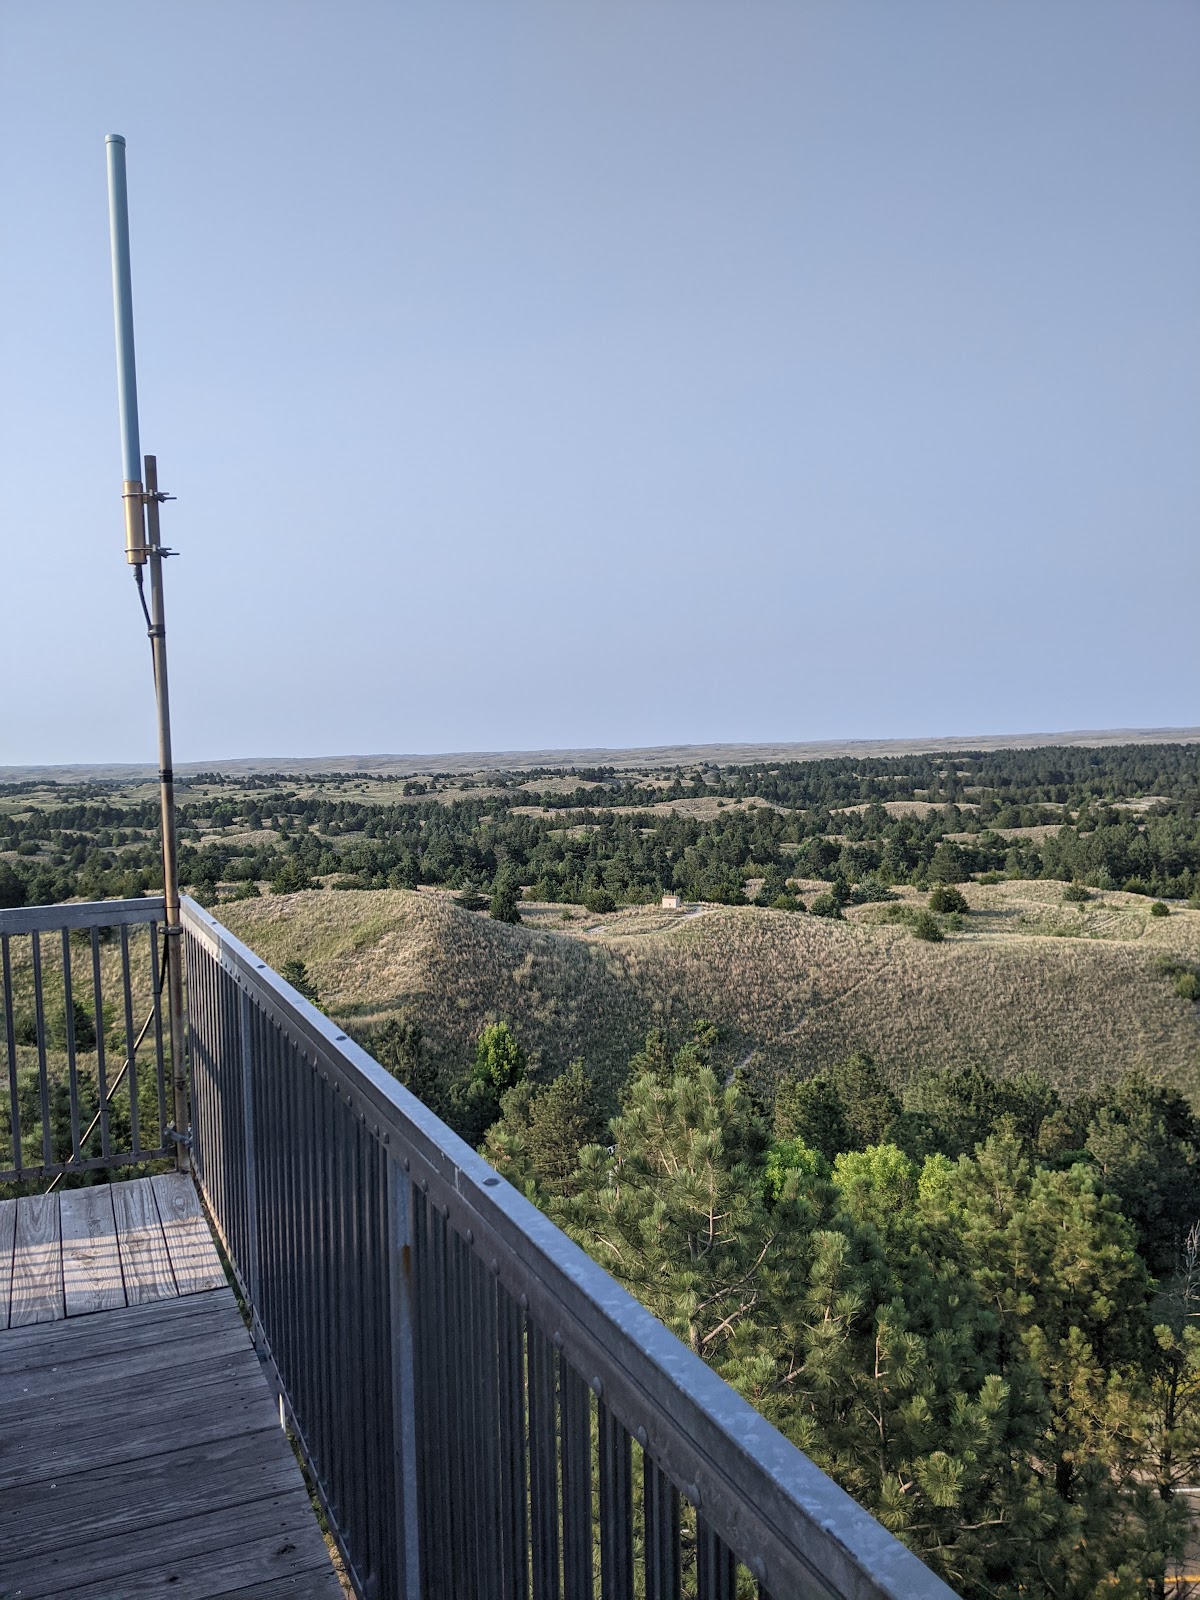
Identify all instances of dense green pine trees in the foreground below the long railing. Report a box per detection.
[480,1022,1200,1600]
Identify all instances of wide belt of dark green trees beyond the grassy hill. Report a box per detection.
[0,746,1200,909]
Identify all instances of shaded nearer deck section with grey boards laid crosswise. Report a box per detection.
[0,1288,341,1600]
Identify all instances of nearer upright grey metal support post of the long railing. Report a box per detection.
[387,1160,421,1600]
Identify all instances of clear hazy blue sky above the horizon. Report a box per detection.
[0,0,1200,763]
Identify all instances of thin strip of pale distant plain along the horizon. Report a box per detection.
[0,728,1200,784]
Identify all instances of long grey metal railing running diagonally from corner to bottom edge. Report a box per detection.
[184,901,952,1600]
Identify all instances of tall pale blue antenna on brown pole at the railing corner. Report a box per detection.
[104,133,190,1171]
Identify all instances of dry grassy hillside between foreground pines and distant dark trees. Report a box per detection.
[219,882,1200,1102]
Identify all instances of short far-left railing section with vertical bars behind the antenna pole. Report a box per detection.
[0,899,174,1184]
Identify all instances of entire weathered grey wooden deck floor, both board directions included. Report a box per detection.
[0,1174,342,1600]
